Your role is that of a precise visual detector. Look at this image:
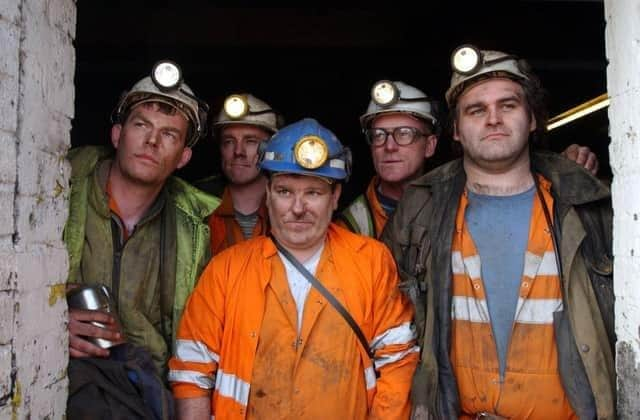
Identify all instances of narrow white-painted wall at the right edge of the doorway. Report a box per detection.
[604,0,640,419]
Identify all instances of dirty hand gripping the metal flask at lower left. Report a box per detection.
[69,308,122,357]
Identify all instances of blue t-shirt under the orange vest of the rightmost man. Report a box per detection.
[464,187,535,378]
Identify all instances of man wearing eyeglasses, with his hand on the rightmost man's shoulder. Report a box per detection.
[338,80,598,238]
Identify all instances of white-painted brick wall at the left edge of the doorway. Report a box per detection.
[0,0,76,419]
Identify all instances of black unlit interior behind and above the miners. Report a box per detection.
[71,0,611,208]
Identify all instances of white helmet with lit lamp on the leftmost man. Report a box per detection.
[111,60,209,147]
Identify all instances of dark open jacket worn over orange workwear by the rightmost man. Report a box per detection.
[382,152,616,419]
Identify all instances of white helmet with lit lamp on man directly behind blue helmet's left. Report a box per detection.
[213,93,282,134]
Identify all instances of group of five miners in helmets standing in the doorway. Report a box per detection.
[64,45,616,419]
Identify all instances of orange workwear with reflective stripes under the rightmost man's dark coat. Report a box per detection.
[450,176,577,420]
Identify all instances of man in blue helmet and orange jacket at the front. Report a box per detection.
[169,119,418,419]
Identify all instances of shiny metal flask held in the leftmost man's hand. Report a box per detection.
[67,284,120,349]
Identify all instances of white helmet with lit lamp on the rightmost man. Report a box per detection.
[445,44,530,106]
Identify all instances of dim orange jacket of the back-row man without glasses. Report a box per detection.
[209,187,269,255]
